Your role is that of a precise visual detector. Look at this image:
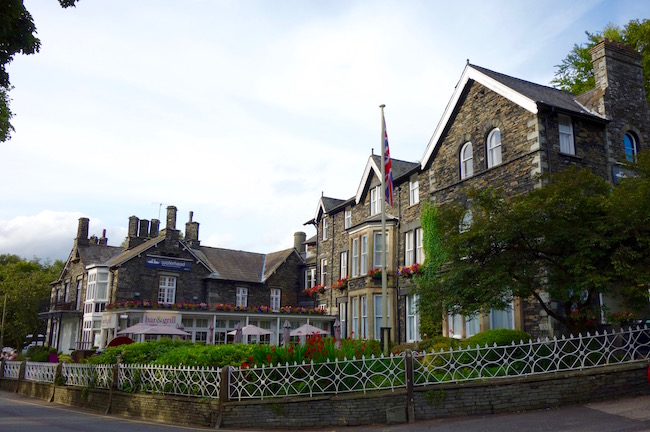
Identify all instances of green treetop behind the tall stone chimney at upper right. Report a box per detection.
[551,19,650,100]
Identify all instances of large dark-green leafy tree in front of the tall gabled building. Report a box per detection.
[416,159,650,338]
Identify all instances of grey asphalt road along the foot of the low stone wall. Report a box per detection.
[0,391,650,432]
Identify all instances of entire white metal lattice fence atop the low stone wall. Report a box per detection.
[3,327,650,400]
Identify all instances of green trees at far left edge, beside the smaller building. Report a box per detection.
[0,255,64,348]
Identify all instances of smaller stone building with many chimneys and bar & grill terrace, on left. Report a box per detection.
[42,206,333,353]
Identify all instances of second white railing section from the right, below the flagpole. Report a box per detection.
[228,355,406,400]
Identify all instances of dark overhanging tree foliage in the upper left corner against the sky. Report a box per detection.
[0,0,78,142]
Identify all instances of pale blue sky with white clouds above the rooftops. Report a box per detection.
[0,0,648,261]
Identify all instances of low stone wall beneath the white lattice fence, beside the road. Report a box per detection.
[0,361,650,429]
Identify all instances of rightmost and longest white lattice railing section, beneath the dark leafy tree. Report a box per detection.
[413,327,650,385]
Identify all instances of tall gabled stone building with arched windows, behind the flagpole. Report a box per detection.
[310,40,650,342]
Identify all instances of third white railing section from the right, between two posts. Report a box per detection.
[117,364,221,398]
